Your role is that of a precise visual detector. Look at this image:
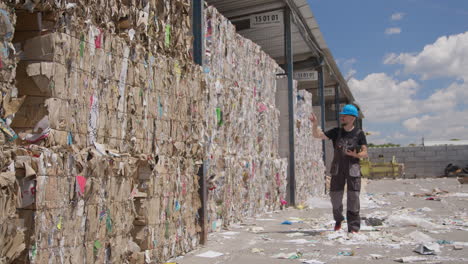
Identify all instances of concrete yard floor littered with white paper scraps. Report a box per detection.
[168,178,468,264]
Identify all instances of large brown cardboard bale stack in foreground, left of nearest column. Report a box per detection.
[2,1,205,263]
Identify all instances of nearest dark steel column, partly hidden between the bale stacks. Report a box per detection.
[192,0,208,245]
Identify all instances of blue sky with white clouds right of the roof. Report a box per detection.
[308,0,468,144]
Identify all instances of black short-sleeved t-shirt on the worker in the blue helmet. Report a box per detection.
[325,127,367,161]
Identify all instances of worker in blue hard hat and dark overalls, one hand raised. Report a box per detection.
[310,104,367,233]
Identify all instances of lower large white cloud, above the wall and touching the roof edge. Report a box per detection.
[348,73,468,138]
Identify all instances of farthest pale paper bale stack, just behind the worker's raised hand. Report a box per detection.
[294,90,325,205]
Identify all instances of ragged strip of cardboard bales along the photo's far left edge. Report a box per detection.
[0,2,26,263]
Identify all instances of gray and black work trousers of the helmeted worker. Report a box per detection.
[330,162,361,232]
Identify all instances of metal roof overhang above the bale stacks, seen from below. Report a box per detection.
[207,0,354,105]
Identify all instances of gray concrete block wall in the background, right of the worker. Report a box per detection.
[369,145,468,178]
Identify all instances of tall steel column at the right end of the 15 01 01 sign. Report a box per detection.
[284,7,296,206]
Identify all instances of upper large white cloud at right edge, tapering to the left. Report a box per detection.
[384,31,468,81]
